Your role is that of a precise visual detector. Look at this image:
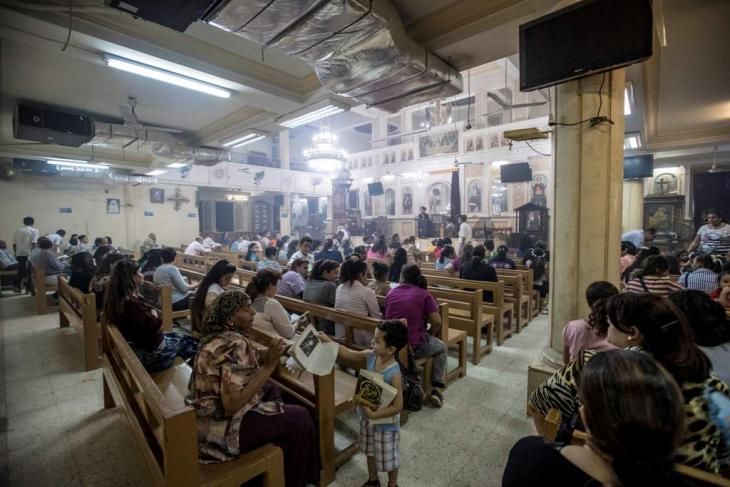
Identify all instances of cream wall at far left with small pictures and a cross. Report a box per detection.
[0,176,198,252]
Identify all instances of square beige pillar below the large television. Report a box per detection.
[546,69,625,361]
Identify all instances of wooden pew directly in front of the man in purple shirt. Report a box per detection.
[428,286,494,365]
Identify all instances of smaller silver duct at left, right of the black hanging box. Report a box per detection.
[87,121,231,166]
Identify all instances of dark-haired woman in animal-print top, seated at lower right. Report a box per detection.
[528,293,730,474]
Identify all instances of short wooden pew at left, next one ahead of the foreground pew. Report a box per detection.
[58,276,103,370]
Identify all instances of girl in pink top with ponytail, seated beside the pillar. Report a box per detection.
[563,281,618,364]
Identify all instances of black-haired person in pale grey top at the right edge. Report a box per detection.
[669,290,730,384]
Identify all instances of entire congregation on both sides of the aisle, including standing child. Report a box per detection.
[17,217,730,487]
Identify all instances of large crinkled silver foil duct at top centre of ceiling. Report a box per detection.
[204,0,463,113]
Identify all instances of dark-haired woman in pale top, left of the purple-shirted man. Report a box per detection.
[335,260,383,346]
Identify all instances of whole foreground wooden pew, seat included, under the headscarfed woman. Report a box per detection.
[102,324,284,487]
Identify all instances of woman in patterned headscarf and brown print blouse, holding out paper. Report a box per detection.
[189,289,319,487]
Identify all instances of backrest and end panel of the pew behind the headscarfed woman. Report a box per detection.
[102,323,200,486]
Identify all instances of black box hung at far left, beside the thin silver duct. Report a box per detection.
[13,105,94,147]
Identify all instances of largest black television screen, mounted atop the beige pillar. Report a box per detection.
[520,0,653,91]
